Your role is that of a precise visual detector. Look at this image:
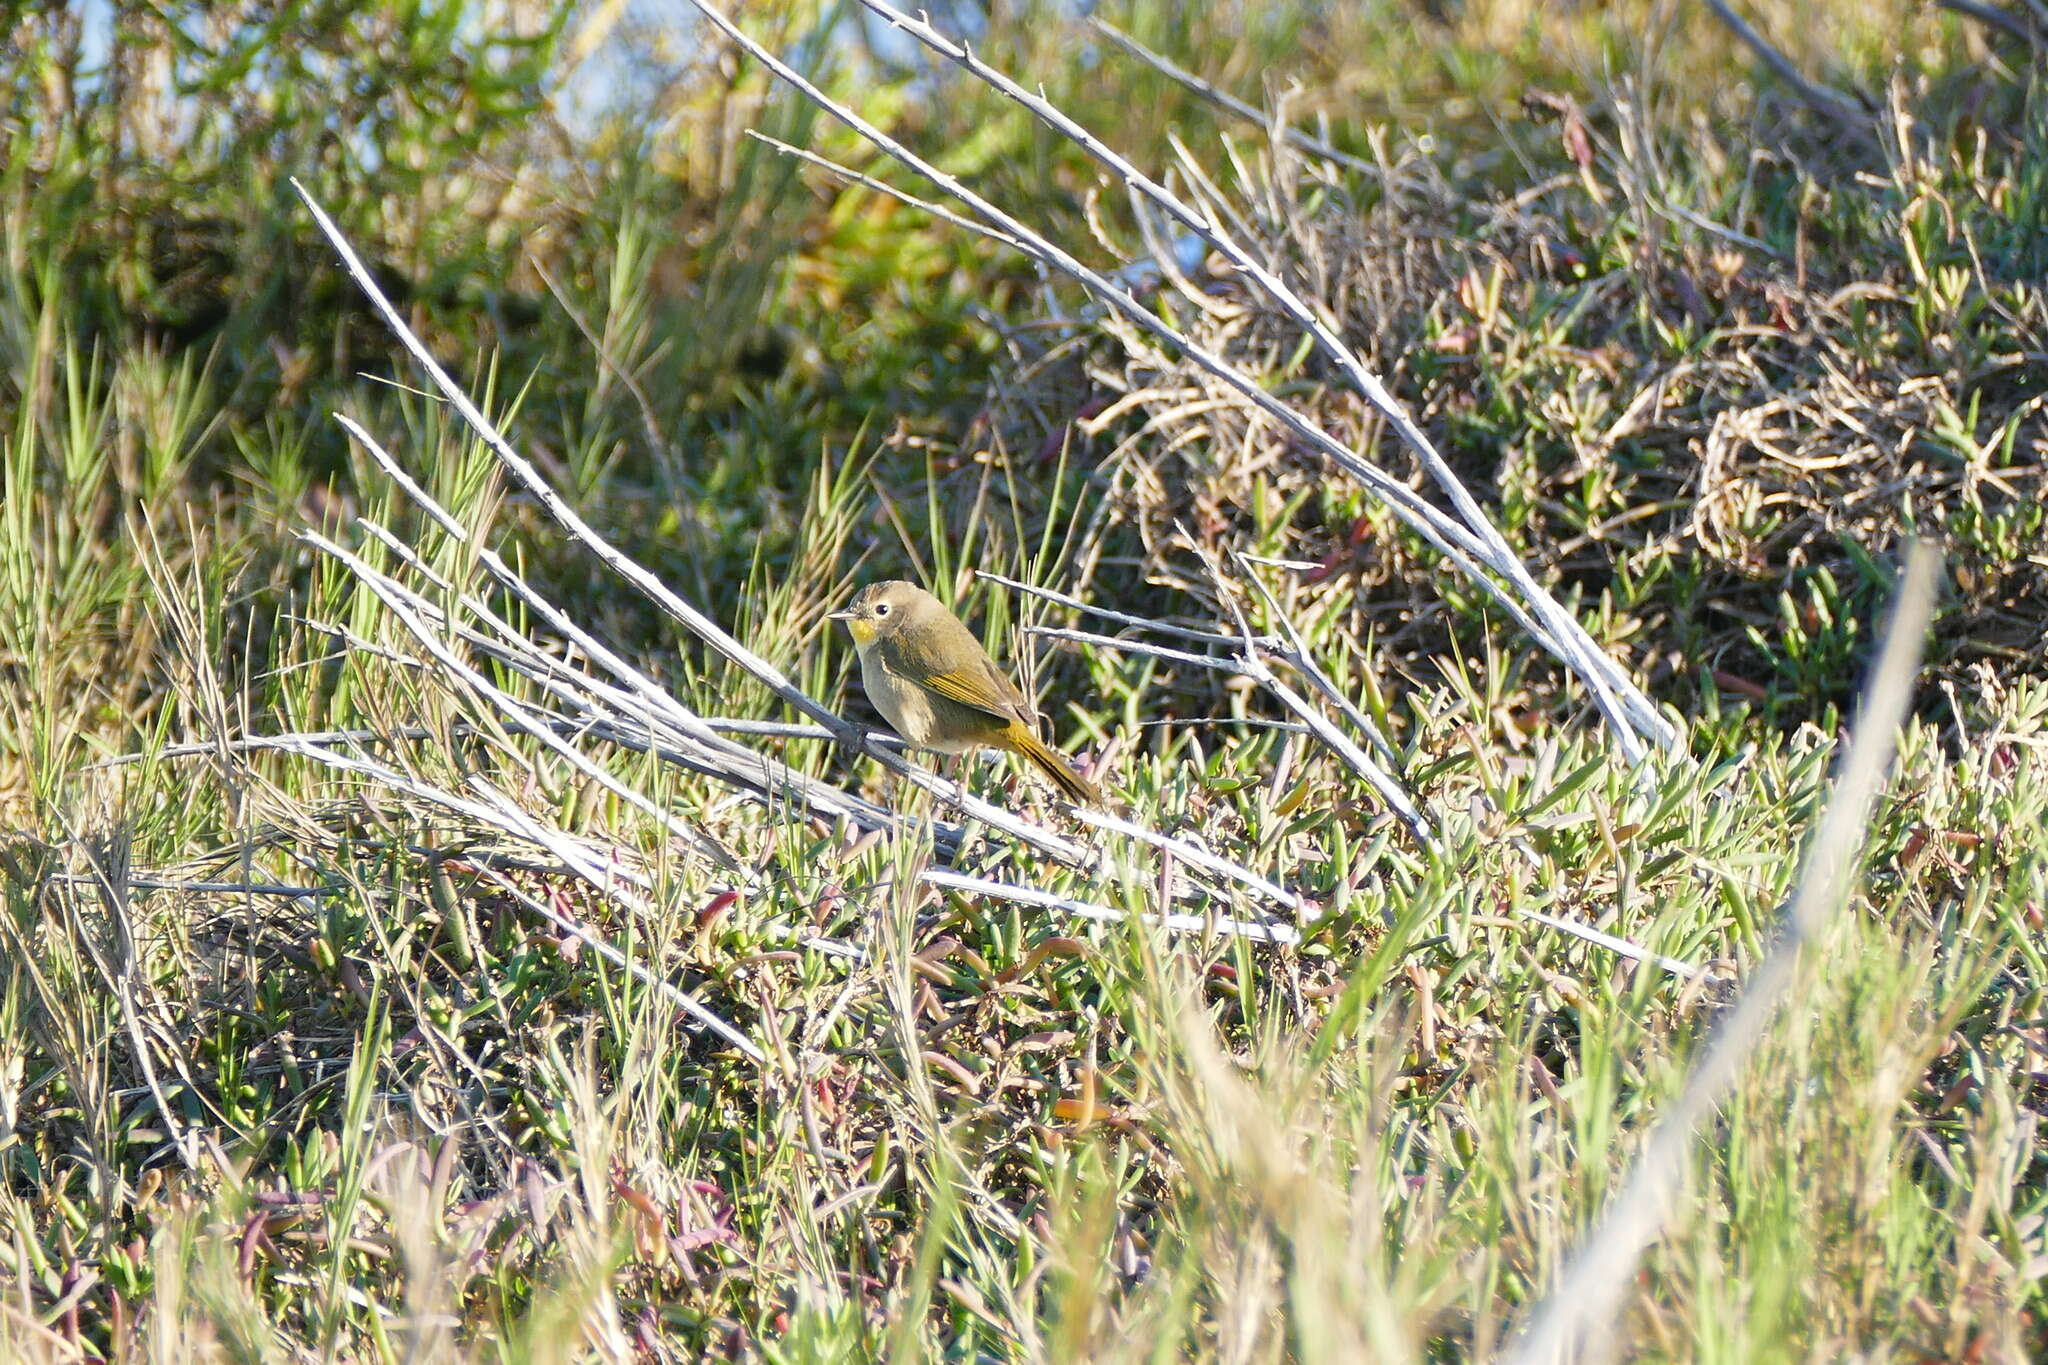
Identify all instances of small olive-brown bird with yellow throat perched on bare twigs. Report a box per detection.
[831,579,1102,806]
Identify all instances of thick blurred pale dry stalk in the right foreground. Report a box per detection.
[1507,544,1935,1365]
